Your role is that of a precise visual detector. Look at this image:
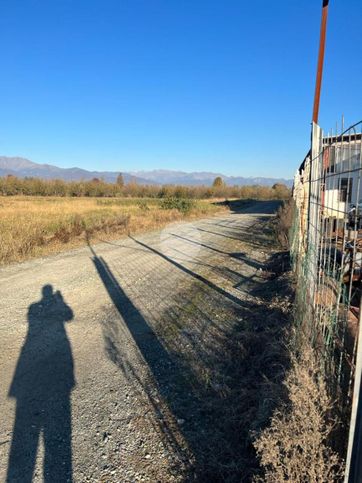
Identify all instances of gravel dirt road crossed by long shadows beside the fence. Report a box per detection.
[0,202,284,483]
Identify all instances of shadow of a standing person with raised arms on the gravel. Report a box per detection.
[6,285,75,483]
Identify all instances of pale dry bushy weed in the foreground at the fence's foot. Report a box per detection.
[254,344,343,483]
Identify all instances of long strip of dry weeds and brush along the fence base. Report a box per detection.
[253,200,344,483]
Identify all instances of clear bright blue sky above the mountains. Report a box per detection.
[0,0,362,177]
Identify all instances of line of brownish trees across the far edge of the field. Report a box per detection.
[0,175,290,199]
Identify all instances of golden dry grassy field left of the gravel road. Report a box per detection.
[0,196,225,265]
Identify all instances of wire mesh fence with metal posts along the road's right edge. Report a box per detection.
[291,121,362,476]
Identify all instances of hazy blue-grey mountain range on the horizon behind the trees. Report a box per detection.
[0,156,293,186]
